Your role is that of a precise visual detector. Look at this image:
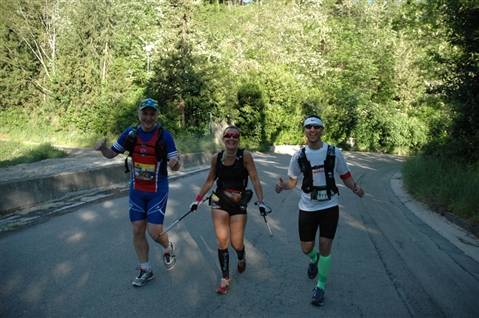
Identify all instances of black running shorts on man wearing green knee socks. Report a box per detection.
[298,206,339,242]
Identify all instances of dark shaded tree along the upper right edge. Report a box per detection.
[426,0,479,163]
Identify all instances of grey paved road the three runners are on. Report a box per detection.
[0,153,479,318]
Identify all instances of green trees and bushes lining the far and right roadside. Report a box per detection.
[0,0,479,227]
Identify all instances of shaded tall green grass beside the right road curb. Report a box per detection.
[402,155,479,225]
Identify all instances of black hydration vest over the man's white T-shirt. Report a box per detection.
[298,145,339,199]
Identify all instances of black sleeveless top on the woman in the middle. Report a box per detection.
[216,149,249,191]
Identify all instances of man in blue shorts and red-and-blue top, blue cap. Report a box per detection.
[95,98,180,287]
